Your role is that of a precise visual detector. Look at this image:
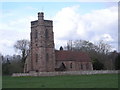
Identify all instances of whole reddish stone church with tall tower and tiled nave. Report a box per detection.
[24,12,93,72]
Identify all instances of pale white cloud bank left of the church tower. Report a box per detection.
[0,16,35,55]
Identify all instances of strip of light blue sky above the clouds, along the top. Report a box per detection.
[2,2,117,15]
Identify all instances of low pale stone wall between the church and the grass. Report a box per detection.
[12,70,119,77]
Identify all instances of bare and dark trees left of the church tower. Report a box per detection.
[0,39,30,75]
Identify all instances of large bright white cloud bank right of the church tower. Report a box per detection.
[53,6,118,49]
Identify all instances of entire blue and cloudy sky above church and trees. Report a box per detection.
[0,2,118,55]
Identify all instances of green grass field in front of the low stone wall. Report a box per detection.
[3,74,118,88]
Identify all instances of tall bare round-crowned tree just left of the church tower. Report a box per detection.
[14,39,30,68]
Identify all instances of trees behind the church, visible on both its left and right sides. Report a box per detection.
[0,40,120,75]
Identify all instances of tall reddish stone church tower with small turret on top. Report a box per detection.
[30,12,55,72]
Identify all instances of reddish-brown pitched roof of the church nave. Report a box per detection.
[55,50,90,62]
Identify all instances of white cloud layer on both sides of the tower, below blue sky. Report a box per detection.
[0,6,118,54]
